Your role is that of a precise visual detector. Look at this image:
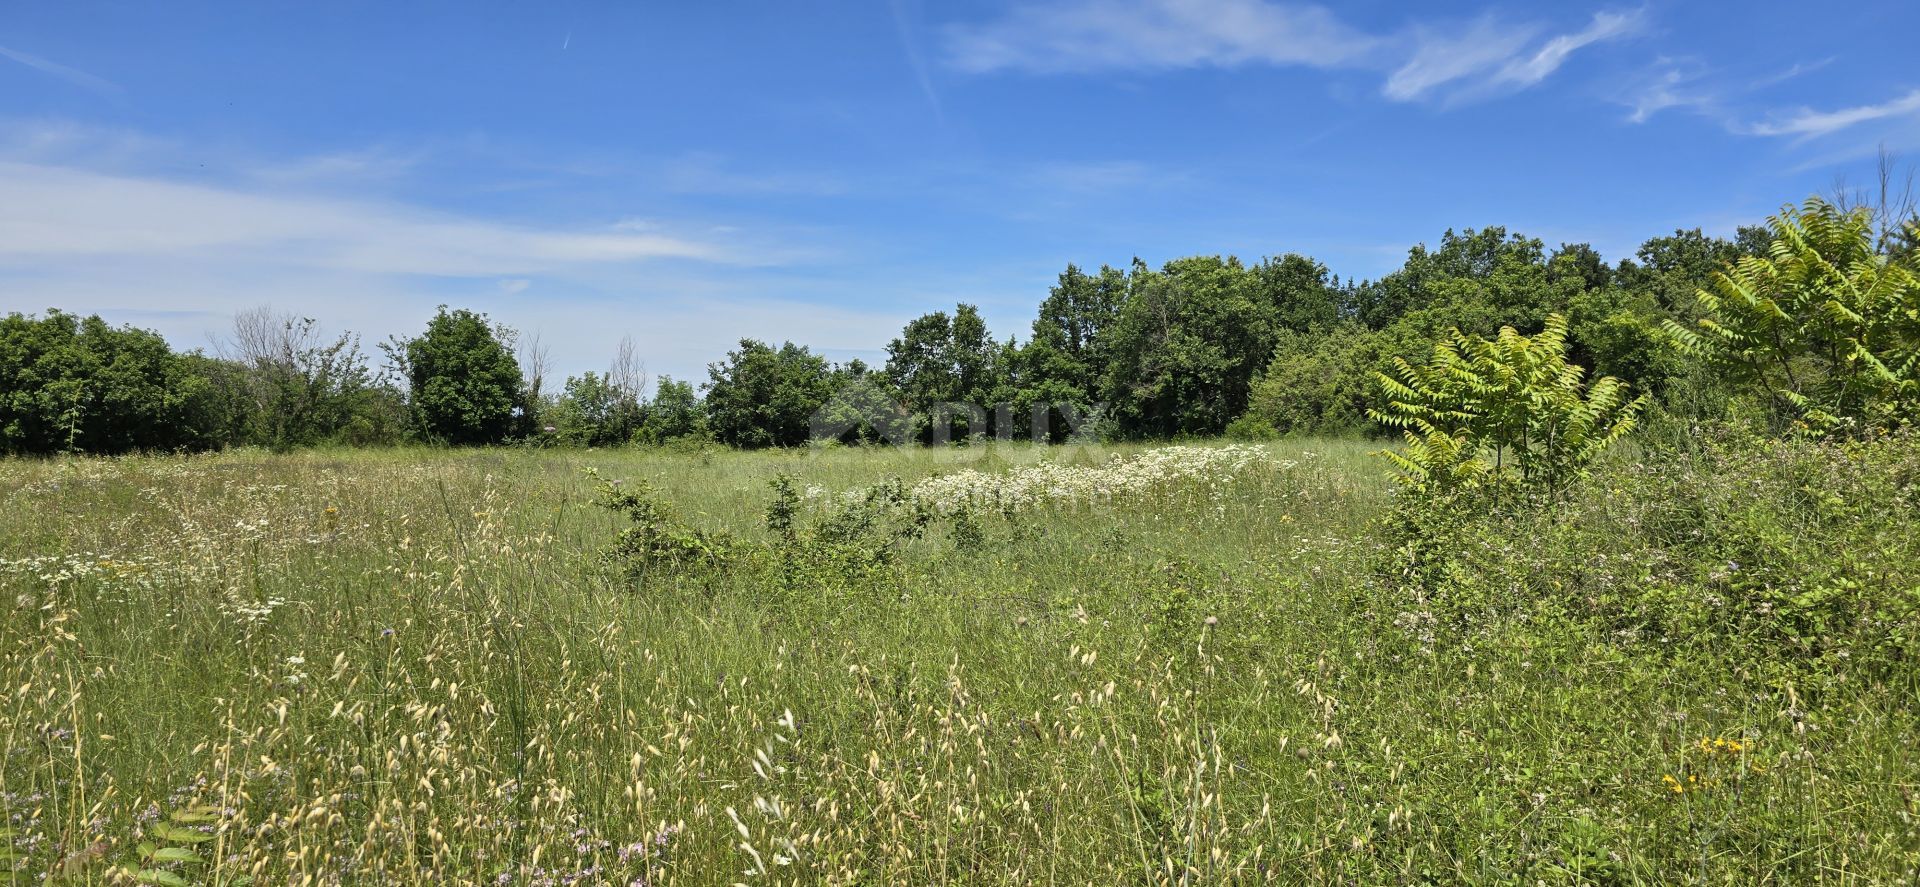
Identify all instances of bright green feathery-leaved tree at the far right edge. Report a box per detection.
[1668,198,1920,434]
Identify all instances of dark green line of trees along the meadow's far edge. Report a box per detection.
[0,186,1920,453]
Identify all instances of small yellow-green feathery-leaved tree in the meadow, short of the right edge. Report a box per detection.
[1373,315,1645,493]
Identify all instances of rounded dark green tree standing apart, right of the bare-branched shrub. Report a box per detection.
[397,305,530,445]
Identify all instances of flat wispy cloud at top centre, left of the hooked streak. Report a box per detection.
[947,0,1380,73]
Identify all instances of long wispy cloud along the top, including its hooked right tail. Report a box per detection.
[947,0,1645,102]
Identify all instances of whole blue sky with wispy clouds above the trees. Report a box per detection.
[0,0,1920,378]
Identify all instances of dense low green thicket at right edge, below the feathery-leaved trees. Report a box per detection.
[1390,428,1920,674]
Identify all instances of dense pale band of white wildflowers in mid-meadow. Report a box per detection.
[908,445,1296,515]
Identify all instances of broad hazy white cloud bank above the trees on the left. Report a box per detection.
[0,123,883,378]
